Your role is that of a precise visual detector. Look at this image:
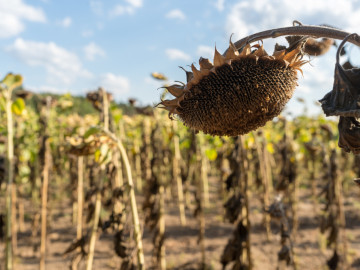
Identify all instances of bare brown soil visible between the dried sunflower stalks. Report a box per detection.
[0,179,360,270]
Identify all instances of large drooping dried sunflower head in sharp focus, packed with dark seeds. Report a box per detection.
[158,40,306,136]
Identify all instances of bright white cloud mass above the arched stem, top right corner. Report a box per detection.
[226,0,360,39]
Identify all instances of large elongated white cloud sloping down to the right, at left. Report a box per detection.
[7,38,93,85]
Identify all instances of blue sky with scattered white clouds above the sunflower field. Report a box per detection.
[0,0,360,113]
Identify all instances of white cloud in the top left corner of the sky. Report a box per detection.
[0,0,46,38]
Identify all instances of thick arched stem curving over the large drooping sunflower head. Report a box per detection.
[228,22,360,55]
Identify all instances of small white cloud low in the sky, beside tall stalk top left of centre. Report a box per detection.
[100,72,130,96]
